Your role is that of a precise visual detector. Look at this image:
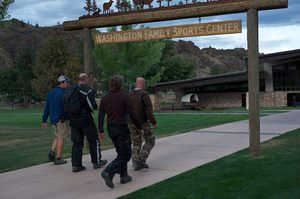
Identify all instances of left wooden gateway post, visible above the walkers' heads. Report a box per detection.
[83,28,93,76]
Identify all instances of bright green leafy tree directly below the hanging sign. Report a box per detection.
[94,26,165,90]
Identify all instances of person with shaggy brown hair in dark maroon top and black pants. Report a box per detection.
[98,75,142,188]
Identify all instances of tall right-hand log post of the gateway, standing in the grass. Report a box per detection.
[247,8,260,156]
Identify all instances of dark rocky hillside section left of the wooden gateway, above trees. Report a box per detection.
[0,19,82,69]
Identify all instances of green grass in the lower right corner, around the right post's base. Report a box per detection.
[121,129,300,199]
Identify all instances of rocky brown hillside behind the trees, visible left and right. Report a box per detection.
[0,19,246,77]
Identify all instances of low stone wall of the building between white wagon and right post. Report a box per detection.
[198,93,243,109]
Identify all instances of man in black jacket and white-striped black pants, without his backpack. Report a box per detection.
[69,73,107,172]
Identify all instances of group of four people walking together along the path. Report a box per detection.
[42,73,157,188]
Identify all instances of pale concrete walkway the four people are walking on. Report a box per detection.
[0,110,300,199]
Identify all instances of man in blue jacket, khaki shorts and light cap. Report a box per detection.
[42,75,70,165]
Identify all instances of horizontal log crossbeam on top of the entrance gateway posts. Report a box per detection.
[63,0,288,30]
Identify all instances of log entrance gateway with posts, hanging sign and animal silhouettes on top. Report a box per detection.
[63,0,288,156]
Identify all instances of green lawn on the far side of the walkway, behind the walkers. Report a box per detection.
[0,110,248,173]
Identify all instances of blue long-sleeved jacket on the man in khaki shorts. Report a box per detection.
[42,87,67,124]
